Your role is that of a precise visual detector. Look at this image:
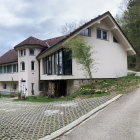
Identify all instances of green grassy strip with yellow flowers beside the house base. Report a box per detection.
[15,73,140,102]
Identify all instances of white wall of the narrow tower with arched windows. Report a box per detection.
[18,46,40,96]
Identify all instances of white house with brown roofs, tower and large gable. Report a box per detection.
[0,12,136,96]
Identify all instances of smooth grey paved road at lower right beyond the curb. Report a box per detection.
[59,88,140,140]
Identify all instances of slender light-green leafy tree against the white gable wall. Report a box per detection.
[64,36,94,78]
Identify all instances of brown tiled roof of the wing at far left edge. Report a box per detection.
[0,49,18,65]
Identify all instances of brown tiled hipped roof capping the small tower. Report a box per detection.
[15,36,48,48]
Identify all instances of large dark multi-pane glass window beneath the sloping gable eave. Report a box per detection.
[43,49,72,75]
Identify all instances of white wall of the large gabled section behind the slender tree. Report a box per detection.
[40,23,127,80]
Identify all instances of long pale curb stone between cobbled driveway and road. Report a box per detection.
[39,94,122,140]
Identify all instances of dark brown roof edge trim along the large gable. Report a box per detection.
[37,11,136,57]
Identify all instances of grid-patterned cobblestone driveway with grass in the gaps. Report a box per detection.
[0,94,115,140]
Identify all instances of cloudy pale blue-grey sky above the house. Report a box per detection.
[0,0,122,56]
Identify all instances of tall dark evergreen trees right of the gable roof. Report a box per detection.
[117,0,140,70]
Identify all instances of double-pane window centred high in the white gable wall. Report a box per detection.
[97,29,108,40]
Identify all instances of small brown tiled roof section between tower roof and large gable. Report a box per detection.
[44,36,66,47]
